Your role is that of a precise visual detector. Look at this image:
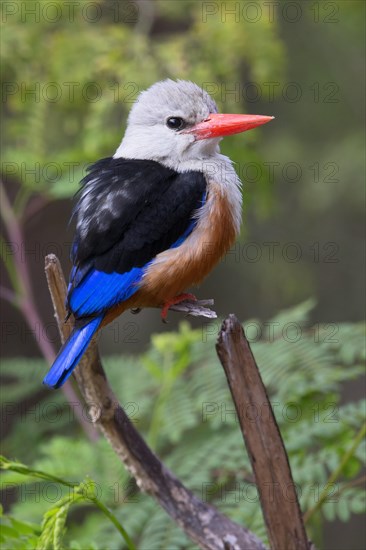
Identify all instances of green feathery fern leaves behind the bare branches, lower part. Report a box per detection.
[3,302,365,550]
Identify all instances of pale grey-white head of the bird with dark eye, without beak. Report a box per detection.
[114,79,221,170]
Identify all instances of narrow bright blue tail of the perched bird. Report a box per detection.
[43,315,103,388]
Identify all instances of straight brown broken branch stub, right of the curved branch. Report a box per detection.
[216,315,314,550]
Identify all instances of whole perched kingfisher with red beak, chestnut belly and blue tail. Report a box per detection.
[43,79,273,388]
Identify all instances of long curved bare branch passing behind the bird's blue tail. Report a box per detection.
[46,255,265,550]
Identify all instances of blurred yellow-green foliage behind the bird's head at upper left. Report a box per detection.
[1,0,285,210]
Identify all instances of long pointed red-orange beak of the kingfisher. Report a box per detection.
[186,113,274,140]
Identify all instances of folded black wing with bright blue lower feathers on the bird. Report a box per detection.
[68,159,206,316]
